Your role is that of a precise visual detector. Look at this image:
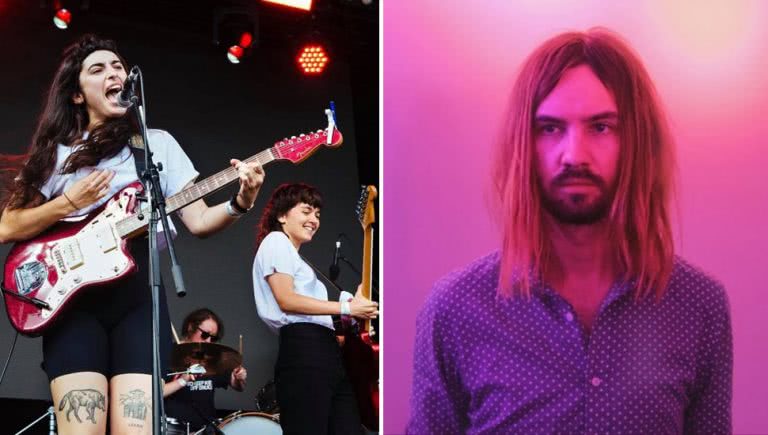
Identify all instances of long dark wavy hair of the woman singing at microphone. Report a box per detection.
[0,34,137,209]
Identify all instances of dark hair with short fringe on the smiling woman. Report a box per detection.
[256,183,323,249]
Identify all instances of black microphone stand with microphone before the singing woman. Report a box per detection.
[130,67,186,434]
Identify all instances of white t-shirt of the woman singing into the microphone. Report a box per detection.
[40,129,199,241]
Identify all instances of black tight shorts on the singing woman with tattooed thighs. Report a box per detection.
[42,238,172,380]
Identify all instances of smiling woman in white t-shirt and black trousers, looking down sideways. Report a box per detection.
[253,183,378,434]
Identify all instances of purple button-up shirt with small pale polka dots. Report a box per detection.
[407,253,733,435]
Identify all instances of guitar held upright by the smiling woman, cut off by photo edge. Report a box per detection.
[342,186,379,432]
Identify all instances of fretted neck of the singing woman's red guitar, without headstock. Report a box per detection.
[115,148,278,238]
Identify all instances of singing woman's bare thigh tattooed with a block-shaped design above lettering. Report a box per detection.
[109,373,152,435]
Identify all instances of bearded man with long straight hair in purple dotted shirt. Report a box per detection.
[408,29,733,434]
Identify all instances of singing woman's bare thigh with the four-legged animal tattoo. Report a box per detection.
[51,372,109,435]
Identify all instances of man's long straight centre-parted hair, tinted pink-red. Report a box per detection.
[492,28,675,297]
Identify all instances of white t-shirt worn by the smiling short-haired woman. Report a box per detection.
[253,231,334,332]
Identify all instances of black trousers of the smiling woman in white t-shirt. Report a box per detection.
[275,323,361,435]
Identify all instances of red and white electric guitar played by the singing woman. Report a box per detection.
[2,111,342,336]
